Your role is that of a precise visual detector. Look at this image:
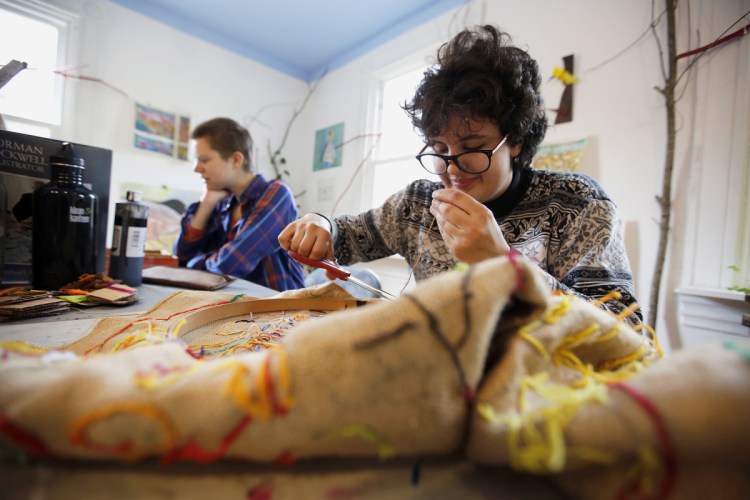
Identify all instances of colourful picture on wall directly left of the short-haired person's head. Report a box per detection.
[133,103,190,160]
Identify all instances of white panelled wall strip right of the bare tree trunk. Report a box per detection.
[661,0,750,347]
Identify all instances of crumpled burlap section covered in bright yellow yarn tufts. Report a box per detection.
[467,296,656,473]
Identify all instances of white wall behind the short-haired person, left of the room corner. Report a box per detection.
[43,0,306,223]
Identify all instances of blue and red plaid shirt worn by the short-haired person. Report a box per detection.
[175,181,304,291]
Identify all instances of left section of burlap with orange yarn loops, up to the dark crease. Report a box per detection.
[0,254,547,462]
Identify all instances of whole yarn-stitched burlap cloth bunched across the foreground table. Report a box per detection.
[0,257,750,498]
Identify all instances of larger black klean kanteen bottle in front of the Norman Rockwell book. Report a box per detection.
[31,142,97,290]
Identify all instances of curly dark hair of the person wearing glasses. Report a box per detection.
[402,25,547,165]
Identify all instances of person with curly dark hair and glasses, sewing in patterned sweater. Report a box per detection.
[279,26,640,323]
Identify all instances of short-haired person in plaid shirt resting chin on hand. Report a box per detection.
[175,118,304,291]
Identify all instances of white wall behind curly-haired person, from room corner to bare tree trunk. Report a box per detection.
[299,0,665,304]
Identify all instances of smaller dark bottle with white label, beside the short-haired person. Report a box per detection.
[109,191,148,286]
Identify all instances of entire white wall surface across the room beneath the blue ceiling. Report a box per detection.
[39,0,750,348]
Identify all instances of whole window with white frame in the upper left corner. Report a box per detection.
[0,0,70,137]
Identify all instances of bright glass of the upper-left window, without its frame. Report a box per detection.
[0,9,60,124]
